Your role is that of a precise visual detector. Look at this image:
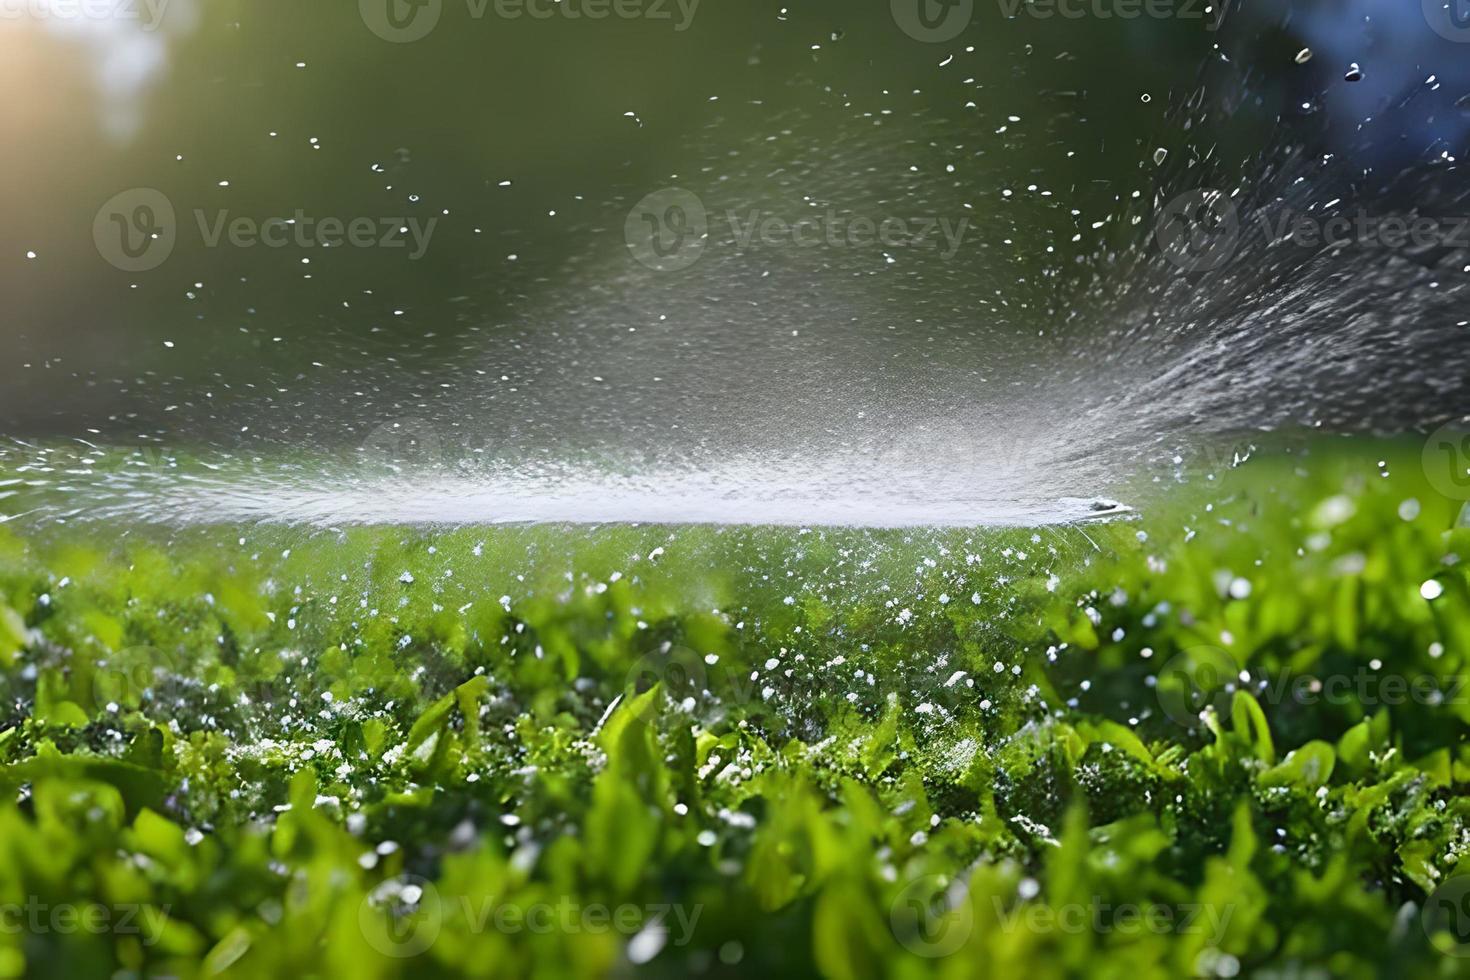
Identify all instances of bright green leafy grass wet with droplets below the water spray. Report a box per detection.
[0,445,1470,980]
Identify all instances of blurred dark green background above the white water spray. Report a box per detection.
[0,0,1470,461]
